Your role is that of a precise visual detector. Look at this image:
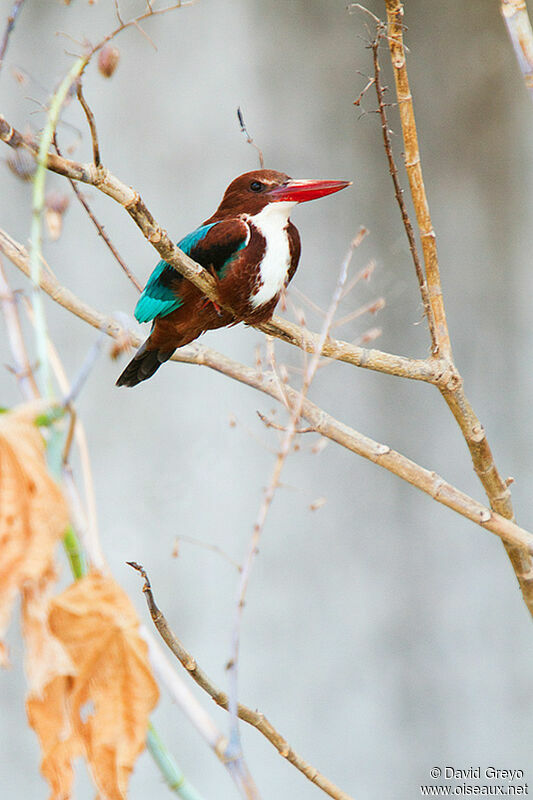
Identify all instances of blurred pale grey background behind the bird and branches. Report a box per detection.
[0,0,533,800]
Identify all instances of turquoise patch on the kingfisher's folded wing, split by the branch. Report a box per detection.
[134,222,216,322]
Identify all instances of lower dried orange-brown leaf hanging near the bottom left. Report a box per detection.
[38,573,158,800]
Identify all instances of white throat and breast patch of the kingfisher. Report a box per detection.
[248,202,297,308]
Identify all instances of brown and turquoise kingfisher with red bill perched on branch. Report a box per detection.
[116,169,351,386]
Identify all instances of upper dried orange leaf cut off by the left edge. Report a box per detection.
[0,406,68,663]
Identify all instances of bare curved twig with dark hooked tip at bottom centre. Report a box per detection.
[128,561,352,800]
